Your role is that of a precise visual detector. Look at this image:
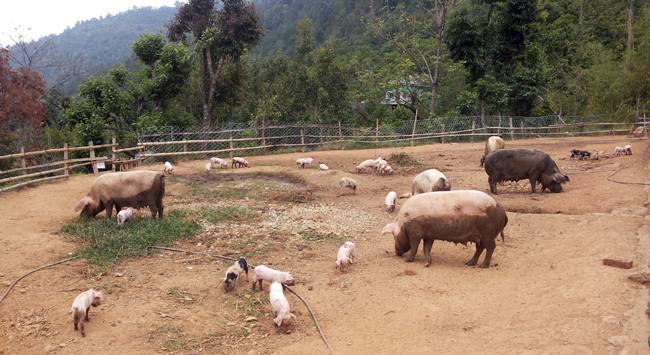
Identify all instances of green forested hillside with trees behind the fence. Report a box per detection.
[0,0,650,155]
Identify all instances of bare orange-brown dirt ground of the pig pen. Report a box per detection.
[0,137,650,354]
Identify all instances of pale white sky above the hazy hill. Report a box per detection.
[0,0,177,47]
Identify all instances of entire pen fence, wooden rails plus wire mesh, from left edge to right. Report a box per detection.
[0,116,636,192]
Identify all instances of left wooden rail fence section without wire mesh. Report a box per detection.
[0,137,143,192]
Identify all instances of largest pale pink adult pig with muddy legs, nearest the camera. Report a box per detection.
[381,190,508,268]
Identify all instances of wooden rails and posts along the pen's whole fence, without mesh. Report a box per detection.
[0,118,634,192]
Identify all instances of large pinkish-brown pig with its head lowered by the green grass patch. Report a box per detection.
[74,170,165,219]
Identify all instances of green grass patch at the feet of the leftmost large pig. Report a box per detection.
[61,210,200,268]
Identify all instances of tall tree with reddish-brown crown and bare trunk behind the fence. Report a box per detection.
[167,0,263,131]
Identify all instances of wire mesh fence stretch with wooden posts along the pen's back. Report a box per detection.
[139,116,634,162]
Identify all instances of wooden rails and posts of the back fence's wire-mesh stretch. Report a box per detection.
[138,118,634,161]
